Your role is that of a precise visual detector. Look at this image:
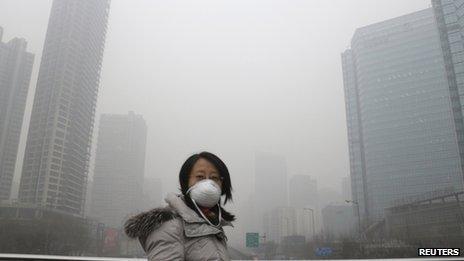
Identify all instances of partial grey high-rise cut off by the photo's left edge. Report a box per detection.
[0,27,34,200]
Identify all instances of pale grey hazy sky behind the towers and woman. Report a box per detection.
[0,0,430,208]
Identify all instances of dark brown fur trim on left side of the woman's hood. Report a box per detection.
[124,206,180,238]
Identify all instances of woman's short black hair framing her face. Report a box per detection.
[179,151,232,205]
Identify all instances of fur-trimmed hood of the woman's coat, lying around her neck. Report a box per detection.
[124,193,235,240]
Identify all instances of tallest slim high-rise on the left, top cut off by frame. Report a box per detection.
[19,0,110,215]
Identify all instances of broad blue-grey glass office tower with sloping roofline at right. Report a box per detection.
[342,8,463,224]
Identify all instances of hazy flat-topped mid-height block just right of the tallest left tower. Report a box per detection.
[90,112,147,228]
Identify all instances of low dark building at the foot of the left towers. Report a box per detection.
[0,202,103,254]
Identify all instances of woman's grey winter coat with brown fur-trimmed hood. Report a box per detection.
[125,194,234,261]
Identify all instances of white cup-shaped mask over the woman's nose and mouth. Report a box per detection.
[187,179,221,208]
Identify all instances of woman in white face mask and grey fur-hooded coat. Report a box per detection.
[124,152,235,260]
